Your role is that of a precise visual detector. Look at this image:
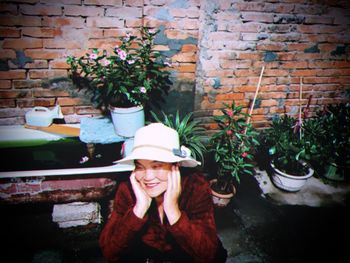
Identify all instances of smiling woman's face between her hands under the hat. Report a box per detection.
[135,160,173,198]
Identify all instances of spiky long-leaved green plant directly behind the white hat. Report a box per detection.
[151,111,207,164]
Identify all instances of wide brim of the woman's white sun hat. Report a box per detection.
[114,149,201,167]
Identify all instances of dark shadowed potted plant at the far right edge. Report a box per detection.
[305,103,350,181]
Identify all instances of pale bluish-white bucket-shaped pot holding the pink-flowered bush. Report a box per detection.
[109,106,145,138]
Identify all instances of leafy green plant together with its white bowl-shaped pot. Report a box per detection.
[259,114,317,192]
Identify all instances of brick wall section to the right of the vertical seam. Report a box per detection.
[196,0,350,128]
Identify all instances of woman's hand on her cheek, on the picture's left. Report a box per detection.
[130,172,152,218]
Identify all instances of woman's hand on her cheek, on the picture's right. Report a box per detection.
[164,164,181,225]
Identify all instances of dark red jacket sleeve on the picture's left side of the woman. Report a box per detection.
[99,182,147,261]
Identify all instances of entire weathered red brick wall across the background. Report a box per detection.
[0,0,350,128]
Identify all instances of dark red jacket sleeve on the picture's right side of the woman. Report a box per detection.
[169,175,218,262]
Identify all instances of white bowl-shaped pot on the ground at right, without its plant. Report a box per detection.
[270,162,314,192]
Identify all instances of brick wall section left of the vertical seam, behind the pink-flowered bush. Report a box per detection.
[0,0,199,125]
